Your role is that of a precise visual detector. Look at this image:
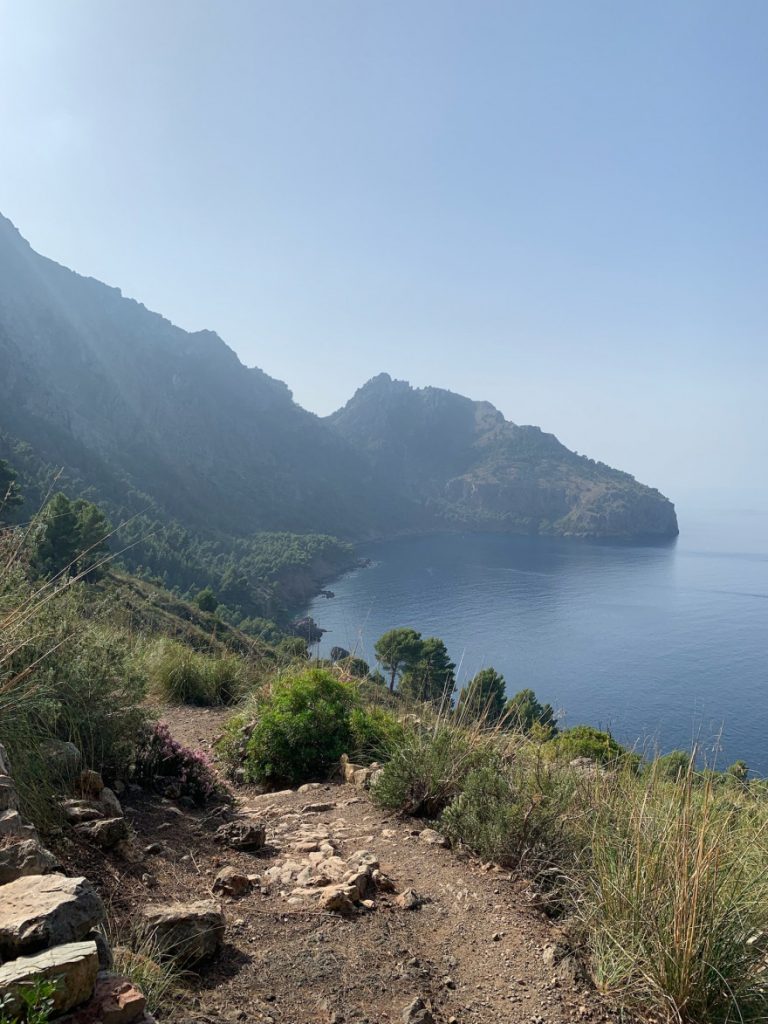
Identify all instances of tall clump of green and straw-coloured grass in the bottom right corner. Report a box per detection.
[575,766,768,1024]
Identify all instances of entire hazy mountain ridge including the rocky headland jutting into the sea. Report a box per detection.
[0,217,677,552]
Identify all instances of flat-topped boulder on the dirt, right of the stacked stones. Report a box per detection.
[141,900,225,967]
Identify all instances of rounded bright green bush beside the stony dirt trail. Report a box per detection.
[244,669,358,785]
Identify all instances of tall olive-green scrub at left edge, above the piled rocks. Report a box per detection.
[0,534,145,829]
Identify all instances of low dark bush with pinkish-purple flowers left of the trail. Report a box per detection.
[132,722,224,805]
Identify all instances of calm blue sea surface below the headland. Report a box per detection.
[308,510,768,775]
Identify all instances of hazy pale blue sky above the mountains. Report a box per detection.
[0,0,768,507]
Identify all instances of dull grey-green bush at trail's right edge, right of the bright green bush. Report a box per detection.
[373,718,490,818]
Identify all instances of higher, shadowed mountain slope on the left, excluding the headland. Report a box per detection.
[0,212,391,534]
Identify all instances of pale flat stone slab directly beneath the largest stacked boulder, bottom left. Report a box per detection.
[0,942,98,1019]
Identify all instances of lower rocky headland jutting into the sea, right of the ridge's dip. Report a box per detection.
[329,374,678,538]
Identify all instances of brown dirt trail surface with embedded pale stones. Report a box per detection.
[61,709,611,1024]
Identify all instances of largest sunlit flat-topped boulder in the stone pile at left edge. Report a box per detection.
[0,873,104,959]
